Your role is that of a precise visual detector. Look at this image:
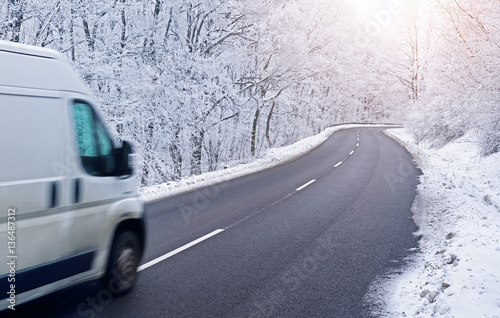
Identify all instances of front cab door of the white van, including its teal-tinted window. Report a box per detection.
[70,99,135,269]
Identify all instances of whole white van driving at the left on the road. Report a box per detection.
[0,41,145,310]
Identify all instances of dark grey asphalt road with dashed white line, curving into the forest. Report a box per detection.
[9,128,419,317]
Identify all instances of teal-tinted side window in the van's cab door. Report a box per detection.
[73,101,115,176]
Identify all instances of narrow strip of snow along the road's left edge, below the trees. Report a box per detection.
[140,124,387,203]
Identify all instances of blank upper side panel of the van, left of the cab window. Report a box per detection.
[0,94,67,182]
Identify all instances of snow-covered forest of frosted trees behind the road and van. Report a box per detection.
[0,0,500,186]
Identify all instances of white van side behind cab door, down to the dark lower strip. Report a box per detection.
[0,89,71,275]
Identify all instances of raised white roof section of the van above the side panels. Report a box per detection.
[0,41,91,95]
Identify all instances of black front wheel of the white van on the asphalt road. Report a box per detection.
[104,232,141,295]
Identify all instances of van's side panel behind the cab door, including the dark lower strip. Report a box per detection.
[0,91,73,299]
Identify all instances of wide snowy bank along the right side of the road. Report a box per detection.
[371,129,500,318]
